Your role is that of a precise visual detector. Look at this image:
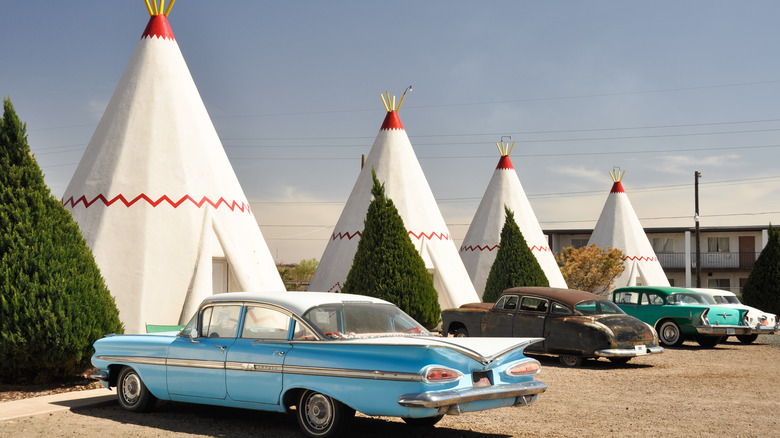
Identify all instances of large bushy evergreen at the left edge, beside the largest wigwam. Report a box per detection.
[0,98,122,383]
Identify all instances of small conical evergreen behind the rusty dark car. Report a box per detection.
[482,206,550,303]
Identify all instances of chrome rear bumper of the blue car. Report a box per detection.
[398,380,547,413]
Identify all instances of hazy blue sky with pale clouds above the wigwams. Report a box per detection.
[0,0,780,263]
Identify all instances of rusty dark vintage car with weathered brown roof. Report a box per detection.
[442,287,664,366]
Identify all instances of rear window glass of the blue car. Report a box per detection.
[303,302,430,339]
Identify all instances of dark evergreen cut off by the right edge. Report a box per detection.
[742,224,780,315]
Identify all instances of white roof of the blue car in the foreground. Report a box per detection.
[203,291,390,315]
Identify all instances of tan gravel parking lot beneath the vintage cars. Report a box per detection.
[0,335,780,438]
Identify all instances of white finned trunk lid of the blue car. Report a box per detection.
[331,336,544,364]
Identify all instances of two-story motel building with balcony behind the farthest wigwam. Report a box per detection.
[544,226,769,294]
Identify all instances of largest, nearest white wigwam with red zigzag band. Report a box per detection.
[63,1,285,333]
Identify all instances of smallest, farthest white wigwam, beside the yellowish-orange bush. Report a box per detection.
[588,170,669,288]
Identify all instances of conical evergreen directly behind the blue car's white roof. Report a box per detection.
[342,169,441,328]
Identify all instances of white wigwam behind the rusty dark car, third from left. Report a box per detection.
[460,140,567,297]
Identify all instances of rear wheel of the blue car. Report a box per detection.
[297,390,355,438]
